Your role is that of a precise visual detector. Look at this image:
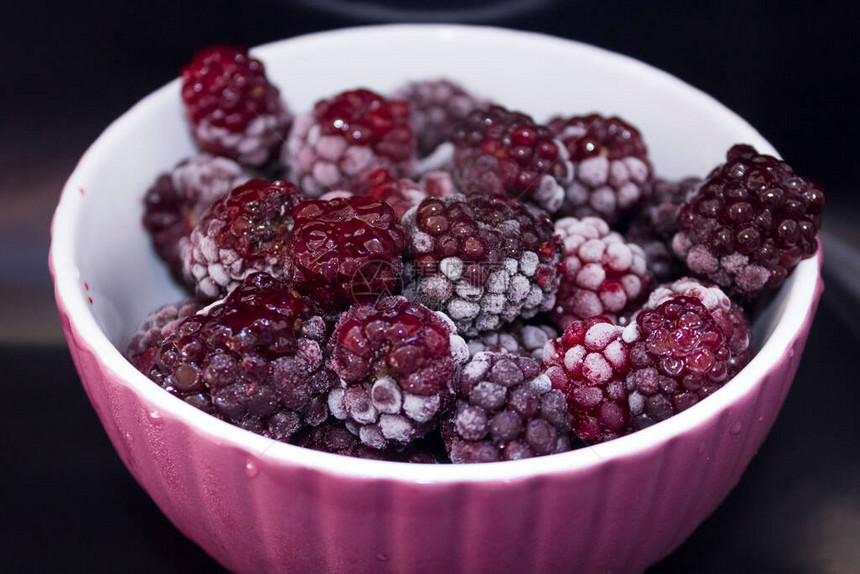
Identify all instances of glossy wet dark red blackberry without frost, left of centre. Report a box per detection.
[285,197,406,313]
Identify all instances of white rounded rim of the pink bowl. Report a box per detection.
[49,24,821,484]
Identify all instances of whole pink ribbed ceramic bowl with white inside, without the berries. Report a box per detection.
[50,26,821,573]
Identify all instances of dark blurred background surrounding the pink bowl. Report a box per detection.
[0,0,860,573]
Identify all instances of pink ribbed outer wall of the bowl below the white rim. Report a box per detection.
[60,280,821,574]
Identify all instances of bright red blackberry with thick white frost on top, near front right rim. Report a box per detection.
[543,317,631,442]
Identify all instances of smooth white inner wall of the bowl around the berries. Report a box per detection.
[52,25,816,482]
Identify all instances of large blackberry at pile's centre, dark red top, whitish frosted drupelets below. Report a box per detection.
[403,195,560,337]
